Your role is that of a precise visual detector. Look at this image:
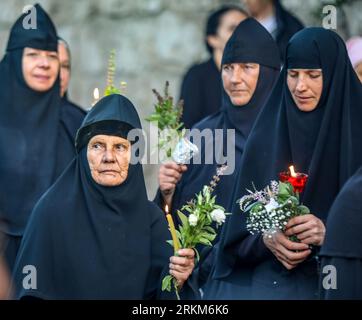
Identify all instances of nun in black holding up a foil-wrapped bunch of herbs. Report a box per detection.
[155,18,280,299]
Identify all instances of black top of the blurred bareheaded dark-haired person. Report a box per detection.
[180,58,222,129]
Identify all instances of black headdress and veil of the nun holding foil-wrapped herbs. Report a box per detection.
[164,18,280,222]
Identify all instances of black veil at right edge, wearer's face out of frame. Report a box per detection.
[320,167,362,259]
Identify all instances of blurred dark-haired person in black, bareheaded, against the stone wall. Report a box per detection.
[180,6,247,128]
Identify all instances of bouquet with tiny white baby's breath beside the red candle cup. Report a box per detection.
[238,181,310,242]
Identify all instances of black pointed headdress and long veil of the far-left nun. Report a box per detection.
[0,5,63,235]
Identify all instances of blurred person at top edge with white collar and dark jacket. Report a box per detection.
[242,0,304,61]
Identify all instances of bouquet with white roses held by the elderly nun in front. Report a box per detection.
[162,165,230,298]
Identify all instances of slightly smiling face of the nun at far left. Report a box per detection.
[22,48,59,92]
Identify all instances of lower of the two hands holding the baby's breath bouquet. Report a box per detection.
[263,231,311,270]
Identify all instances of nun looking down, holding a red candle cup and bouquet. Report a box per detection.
[213,28,362,299]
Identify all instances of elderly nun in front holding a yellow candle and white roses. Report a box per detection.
[14,95,194,299]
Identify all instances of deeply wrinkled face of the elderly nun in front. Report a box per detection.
[87,135,131,187]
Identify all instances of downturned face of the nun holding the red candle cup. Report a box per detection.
[287,69,323,112]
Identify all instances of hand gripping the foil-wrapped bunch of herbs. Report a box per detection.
[158,161,187,205]
